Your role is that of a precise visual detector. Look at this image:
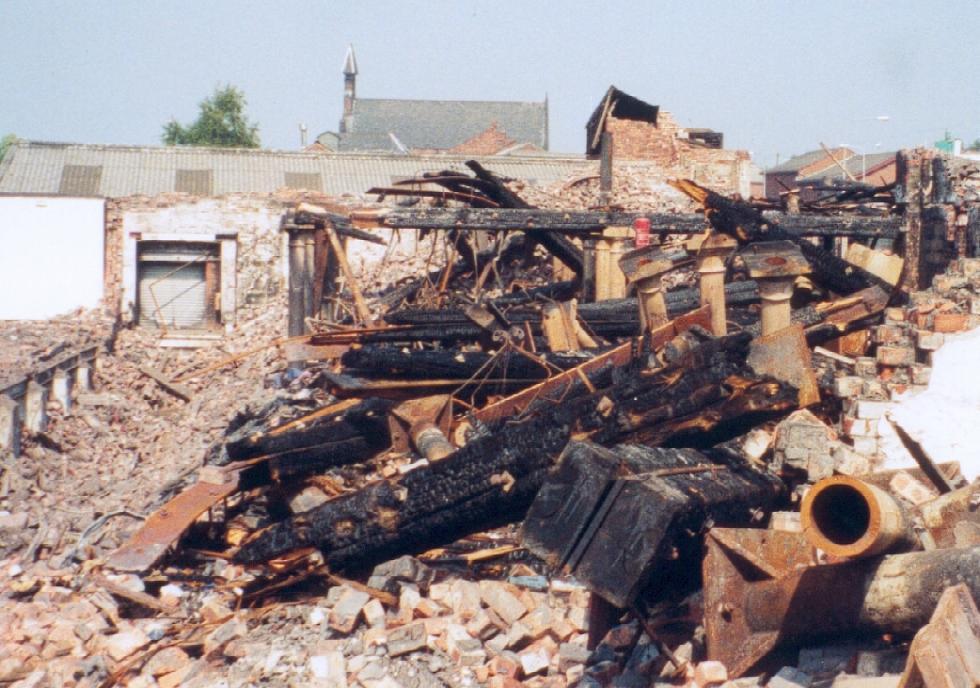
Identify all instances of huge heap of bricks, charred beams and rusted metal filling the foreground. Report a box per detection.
[0,169,980,688]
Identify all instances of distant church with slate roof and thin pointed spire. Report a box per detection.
[322,47,548,155]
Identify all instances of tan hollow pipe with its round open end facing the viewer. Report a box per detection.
[800,475,917,558]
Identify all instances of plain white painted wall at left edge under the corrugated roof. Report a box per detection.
[0,196,105,320]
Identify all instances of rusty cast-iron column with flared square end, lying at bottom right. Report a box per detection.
[703,528,980,676]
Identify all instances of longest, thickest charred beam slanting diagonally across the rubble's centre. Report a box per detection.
[236,335,796,568]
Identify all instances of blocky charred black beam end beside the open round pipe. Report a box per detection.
[521,442,786,609]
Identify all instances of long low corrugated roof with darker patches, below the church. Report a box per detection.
[0,141,594,198]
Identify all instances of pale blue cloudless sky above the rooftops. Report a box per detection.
[0,0,980,165]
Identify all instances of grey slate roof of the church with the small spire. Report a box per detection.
[339,98,548,152]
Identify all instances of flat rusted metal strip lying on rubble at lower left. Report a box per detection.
[107,473,238,571]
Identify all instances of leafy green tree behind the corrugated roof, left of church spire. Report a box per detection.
[163,84,259,148]
